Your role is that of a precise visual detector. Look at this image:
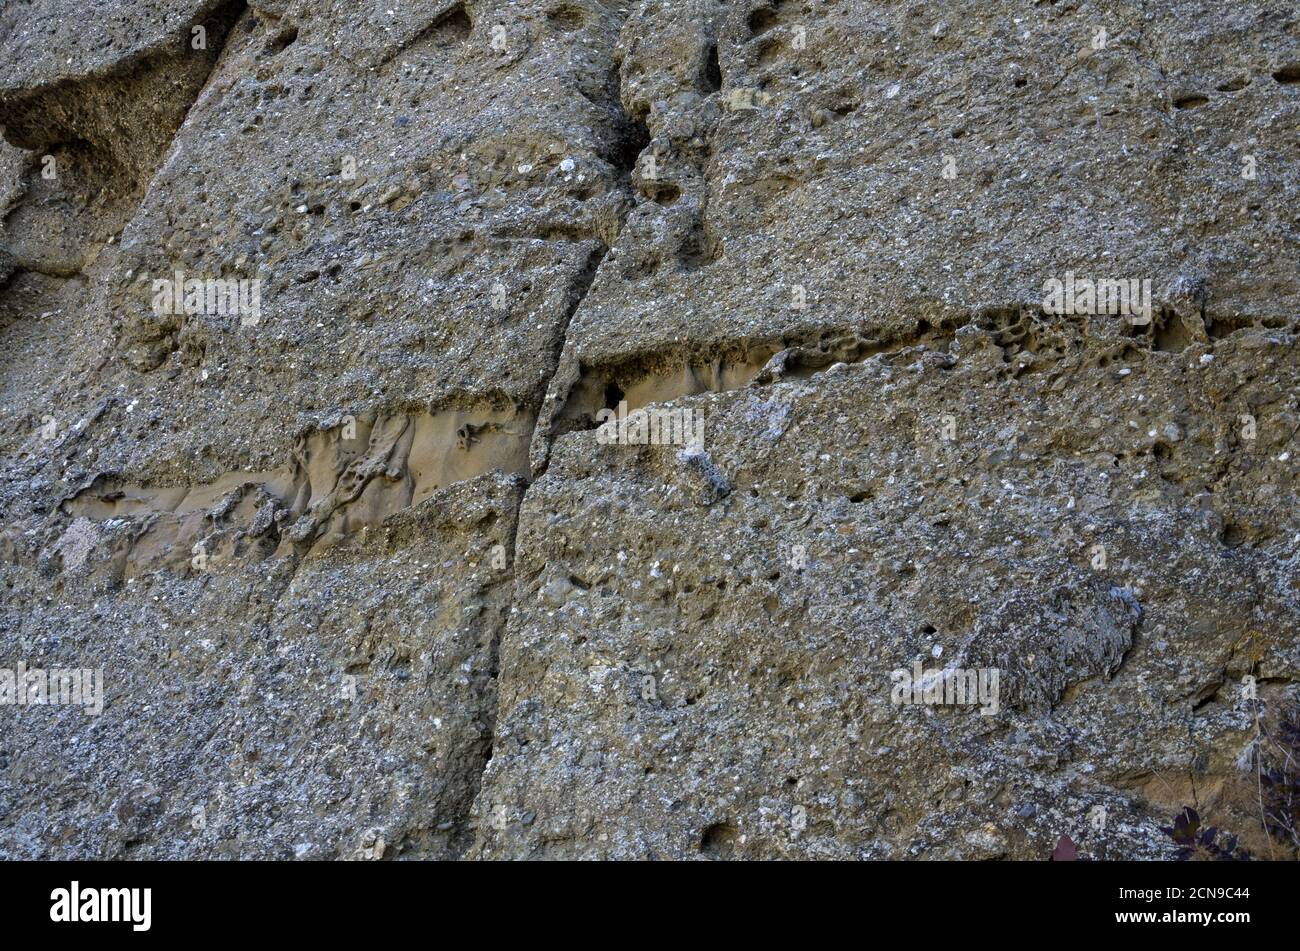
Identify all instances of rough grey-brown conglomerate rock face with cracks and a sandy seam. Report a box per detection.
[0,0,1300,859]
